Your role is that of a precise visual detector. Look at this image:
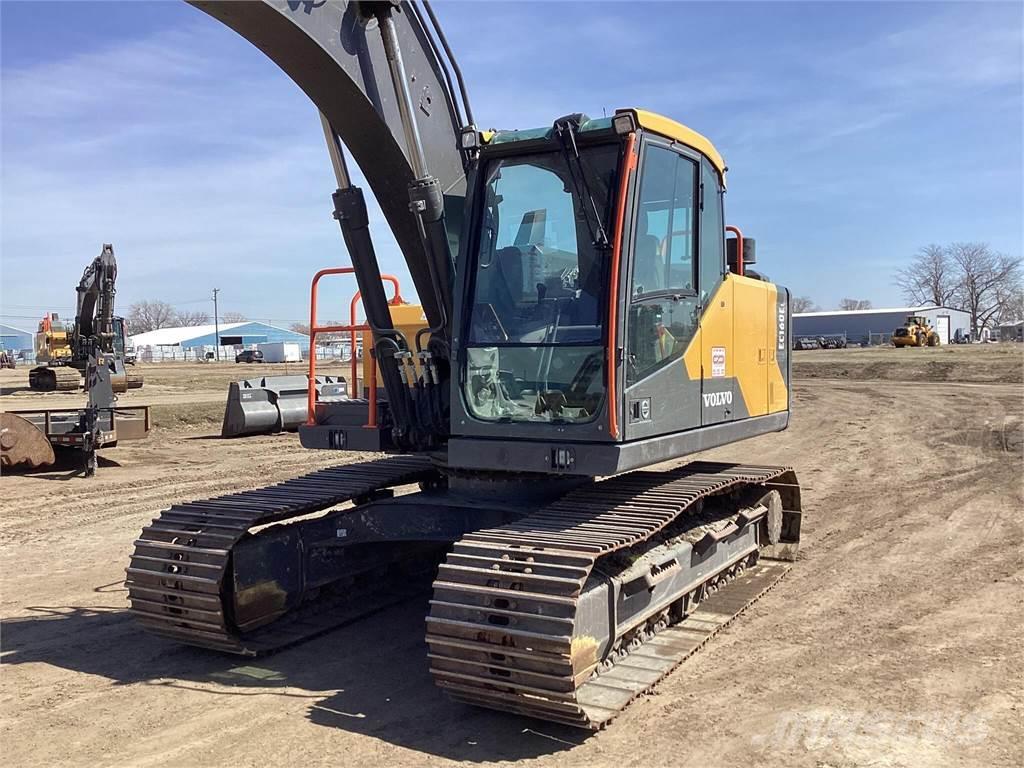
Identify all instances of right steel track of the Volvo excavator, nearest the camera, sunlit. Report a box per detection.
[427,463,799,729]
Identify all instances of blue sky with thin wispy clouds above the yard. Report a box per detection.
[0,0,1024,328]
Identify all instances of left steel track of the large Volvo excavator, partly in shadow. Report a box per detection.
[126,457,436,655]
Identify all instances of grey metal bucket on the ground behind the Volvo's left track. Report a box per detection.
[220,376,348,437]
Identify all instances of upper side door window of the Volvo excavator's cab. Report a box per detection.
[632,144,697,297]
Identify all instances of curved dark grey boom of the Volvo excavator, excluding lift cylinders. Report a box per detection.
[188,0,466,335]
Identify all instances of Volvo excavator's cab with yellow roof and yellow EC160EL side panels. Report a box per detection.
[449,110,790,474]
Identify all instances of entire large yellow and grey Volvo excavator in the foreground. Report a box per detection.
[127,0,801,728]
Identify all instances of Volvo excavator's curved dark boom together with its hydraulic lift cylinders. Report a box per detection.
[189,0,477,451]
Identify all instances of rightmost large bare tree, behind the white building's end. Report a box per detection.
[949,243,1021,335]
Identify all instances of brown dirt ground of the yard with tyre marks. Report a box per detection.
[0,345,1024,768]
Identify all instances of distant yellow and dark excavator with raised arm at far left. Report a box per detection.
[29,244,143,392]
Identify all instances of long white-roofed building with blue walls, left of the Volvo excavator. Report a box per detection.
[131,321,309,360]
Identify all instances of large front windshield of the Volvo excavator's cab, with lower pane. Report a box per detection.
[463,144,620,422]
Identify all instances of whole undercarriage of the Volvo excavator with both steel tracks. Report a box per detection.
[128,457,801,728]
